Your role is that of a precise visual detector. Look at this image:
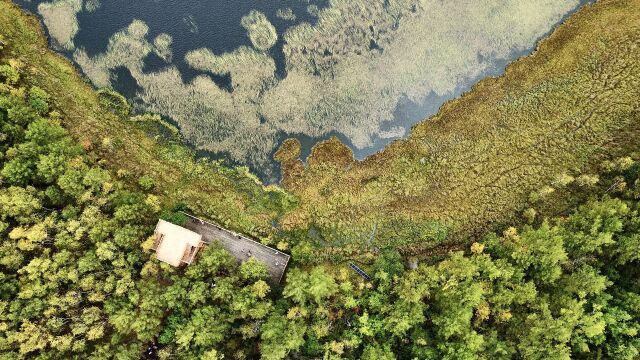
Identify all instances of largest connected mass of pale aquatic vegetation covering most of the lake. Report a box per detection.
[75,0,578,176]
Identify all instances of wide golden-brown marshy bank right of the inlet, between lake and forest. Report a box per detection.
[278,0,640,252]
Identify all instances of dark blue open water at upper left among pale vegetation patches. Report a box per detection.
[16,0,327,93]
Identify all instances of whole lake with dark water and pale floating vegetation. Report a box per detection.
[17,0,589,183]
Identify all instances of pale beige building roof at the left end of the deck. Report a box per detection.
[156,220,202,266]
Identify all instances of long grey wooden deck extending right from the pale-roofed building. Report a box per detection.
[184,214,289,284]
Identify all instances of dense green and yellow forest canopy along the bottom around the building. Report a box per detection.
[0,70,640,359]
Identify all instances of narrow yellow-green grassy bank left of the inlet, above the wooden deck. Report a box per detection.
[0,0,291,242]
